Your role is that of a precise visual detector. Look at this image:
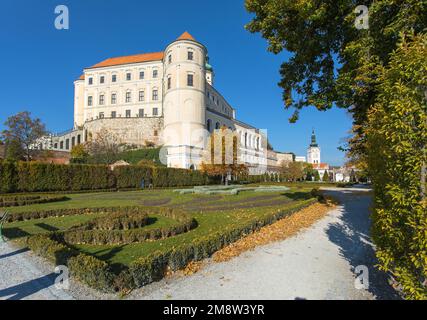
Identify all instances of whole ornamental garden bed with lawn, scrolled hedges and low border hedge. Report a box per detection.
[4,190,317,292]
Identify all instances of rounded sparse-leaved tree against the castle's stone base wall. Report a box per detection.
[86,128,122,164]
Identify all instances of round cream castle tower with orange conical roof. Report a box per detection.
[163,32,207,169]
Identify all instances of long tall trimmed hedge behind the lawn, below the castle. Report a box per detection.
[0,161,212,193]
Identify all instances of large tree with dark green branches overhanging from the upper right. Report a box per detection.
[245,0,427,153]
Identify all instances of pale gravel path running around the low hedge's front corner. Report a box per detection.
[0,189,397,300]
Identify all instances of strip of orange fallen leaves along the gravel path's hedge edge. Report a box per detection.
[213,203,335,262]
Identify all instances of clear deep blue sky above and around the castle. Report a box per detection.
[0,0,351,165]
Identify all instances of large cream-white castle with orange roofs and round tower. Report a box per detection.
[45,32,292,173]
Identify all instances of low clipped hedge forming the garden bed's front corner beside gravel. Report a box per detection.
[22,199,316,292]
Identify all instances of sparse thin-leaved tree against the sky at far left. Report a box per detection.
[1,111,47,161]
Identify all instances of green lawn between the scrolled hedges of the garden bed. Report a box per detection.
[4,185,318,266]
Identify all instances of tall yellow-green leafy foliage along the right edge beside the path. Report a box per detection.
[367,35,427,299]
